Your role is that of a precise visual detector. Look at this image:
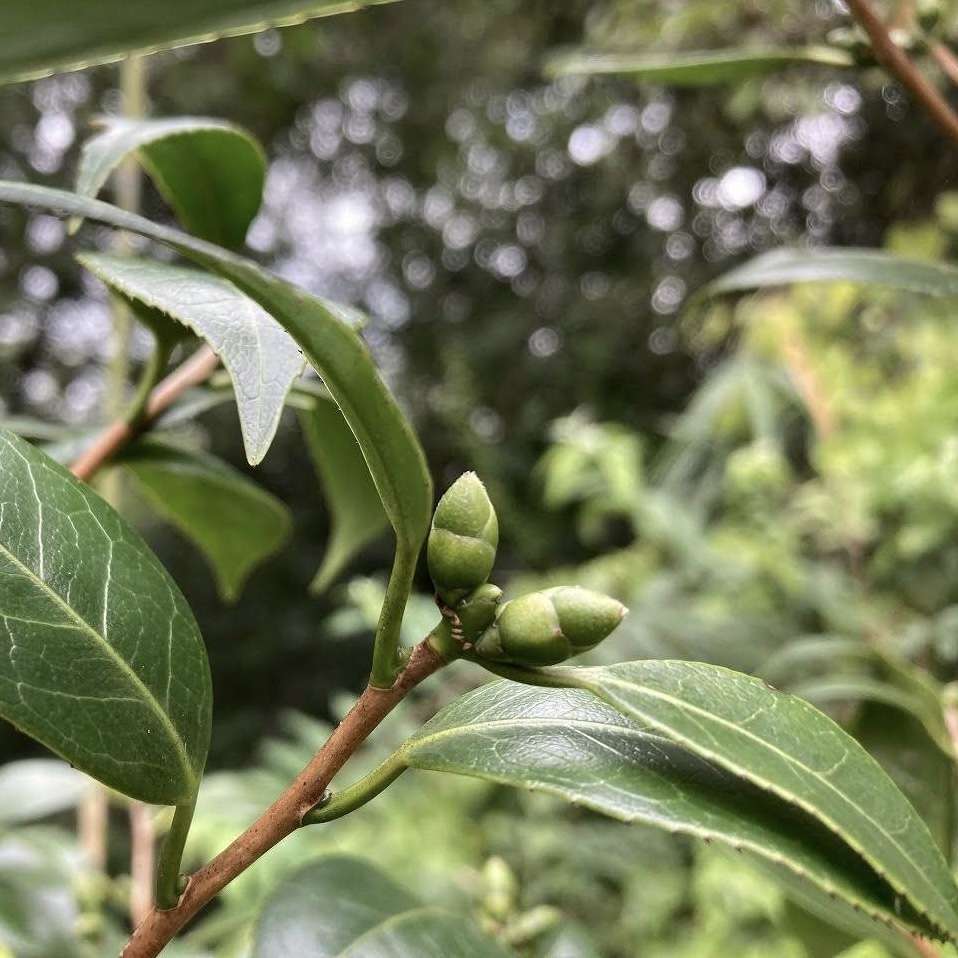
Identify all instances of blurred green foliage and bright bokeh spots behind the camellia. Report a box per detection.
[0,0,958,958]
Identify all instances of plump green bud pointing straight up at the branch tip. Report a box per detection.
[426,472,499,605]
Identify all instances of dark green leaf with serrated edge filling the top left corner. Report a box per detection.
[0,0,400,83]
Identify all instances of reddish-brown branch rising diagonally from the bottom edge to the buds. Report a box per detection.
[121,642,445,958]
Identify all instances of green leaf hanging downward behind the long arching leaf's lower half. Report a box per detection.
[299,396,389,594]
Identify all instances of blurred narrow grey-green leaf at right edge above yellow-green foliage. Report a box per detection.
[703,247,958,297]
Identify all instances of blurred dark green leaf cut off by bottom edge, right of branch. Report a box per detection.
[252,855,508,958]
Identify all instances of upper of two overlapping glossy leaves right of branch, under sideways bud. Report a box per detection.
[564,661,958,938]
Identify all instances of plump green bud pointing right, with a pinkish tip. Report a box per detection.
[476,586,628,665]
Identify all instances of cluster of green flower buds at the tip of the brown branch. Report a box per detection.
[427,472,627,666]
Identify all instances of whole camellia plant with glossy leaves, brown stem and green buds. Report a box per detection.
[0,0,958,958]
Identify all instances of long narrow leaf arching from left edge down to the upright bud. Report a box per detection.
[0,181,432,588]
